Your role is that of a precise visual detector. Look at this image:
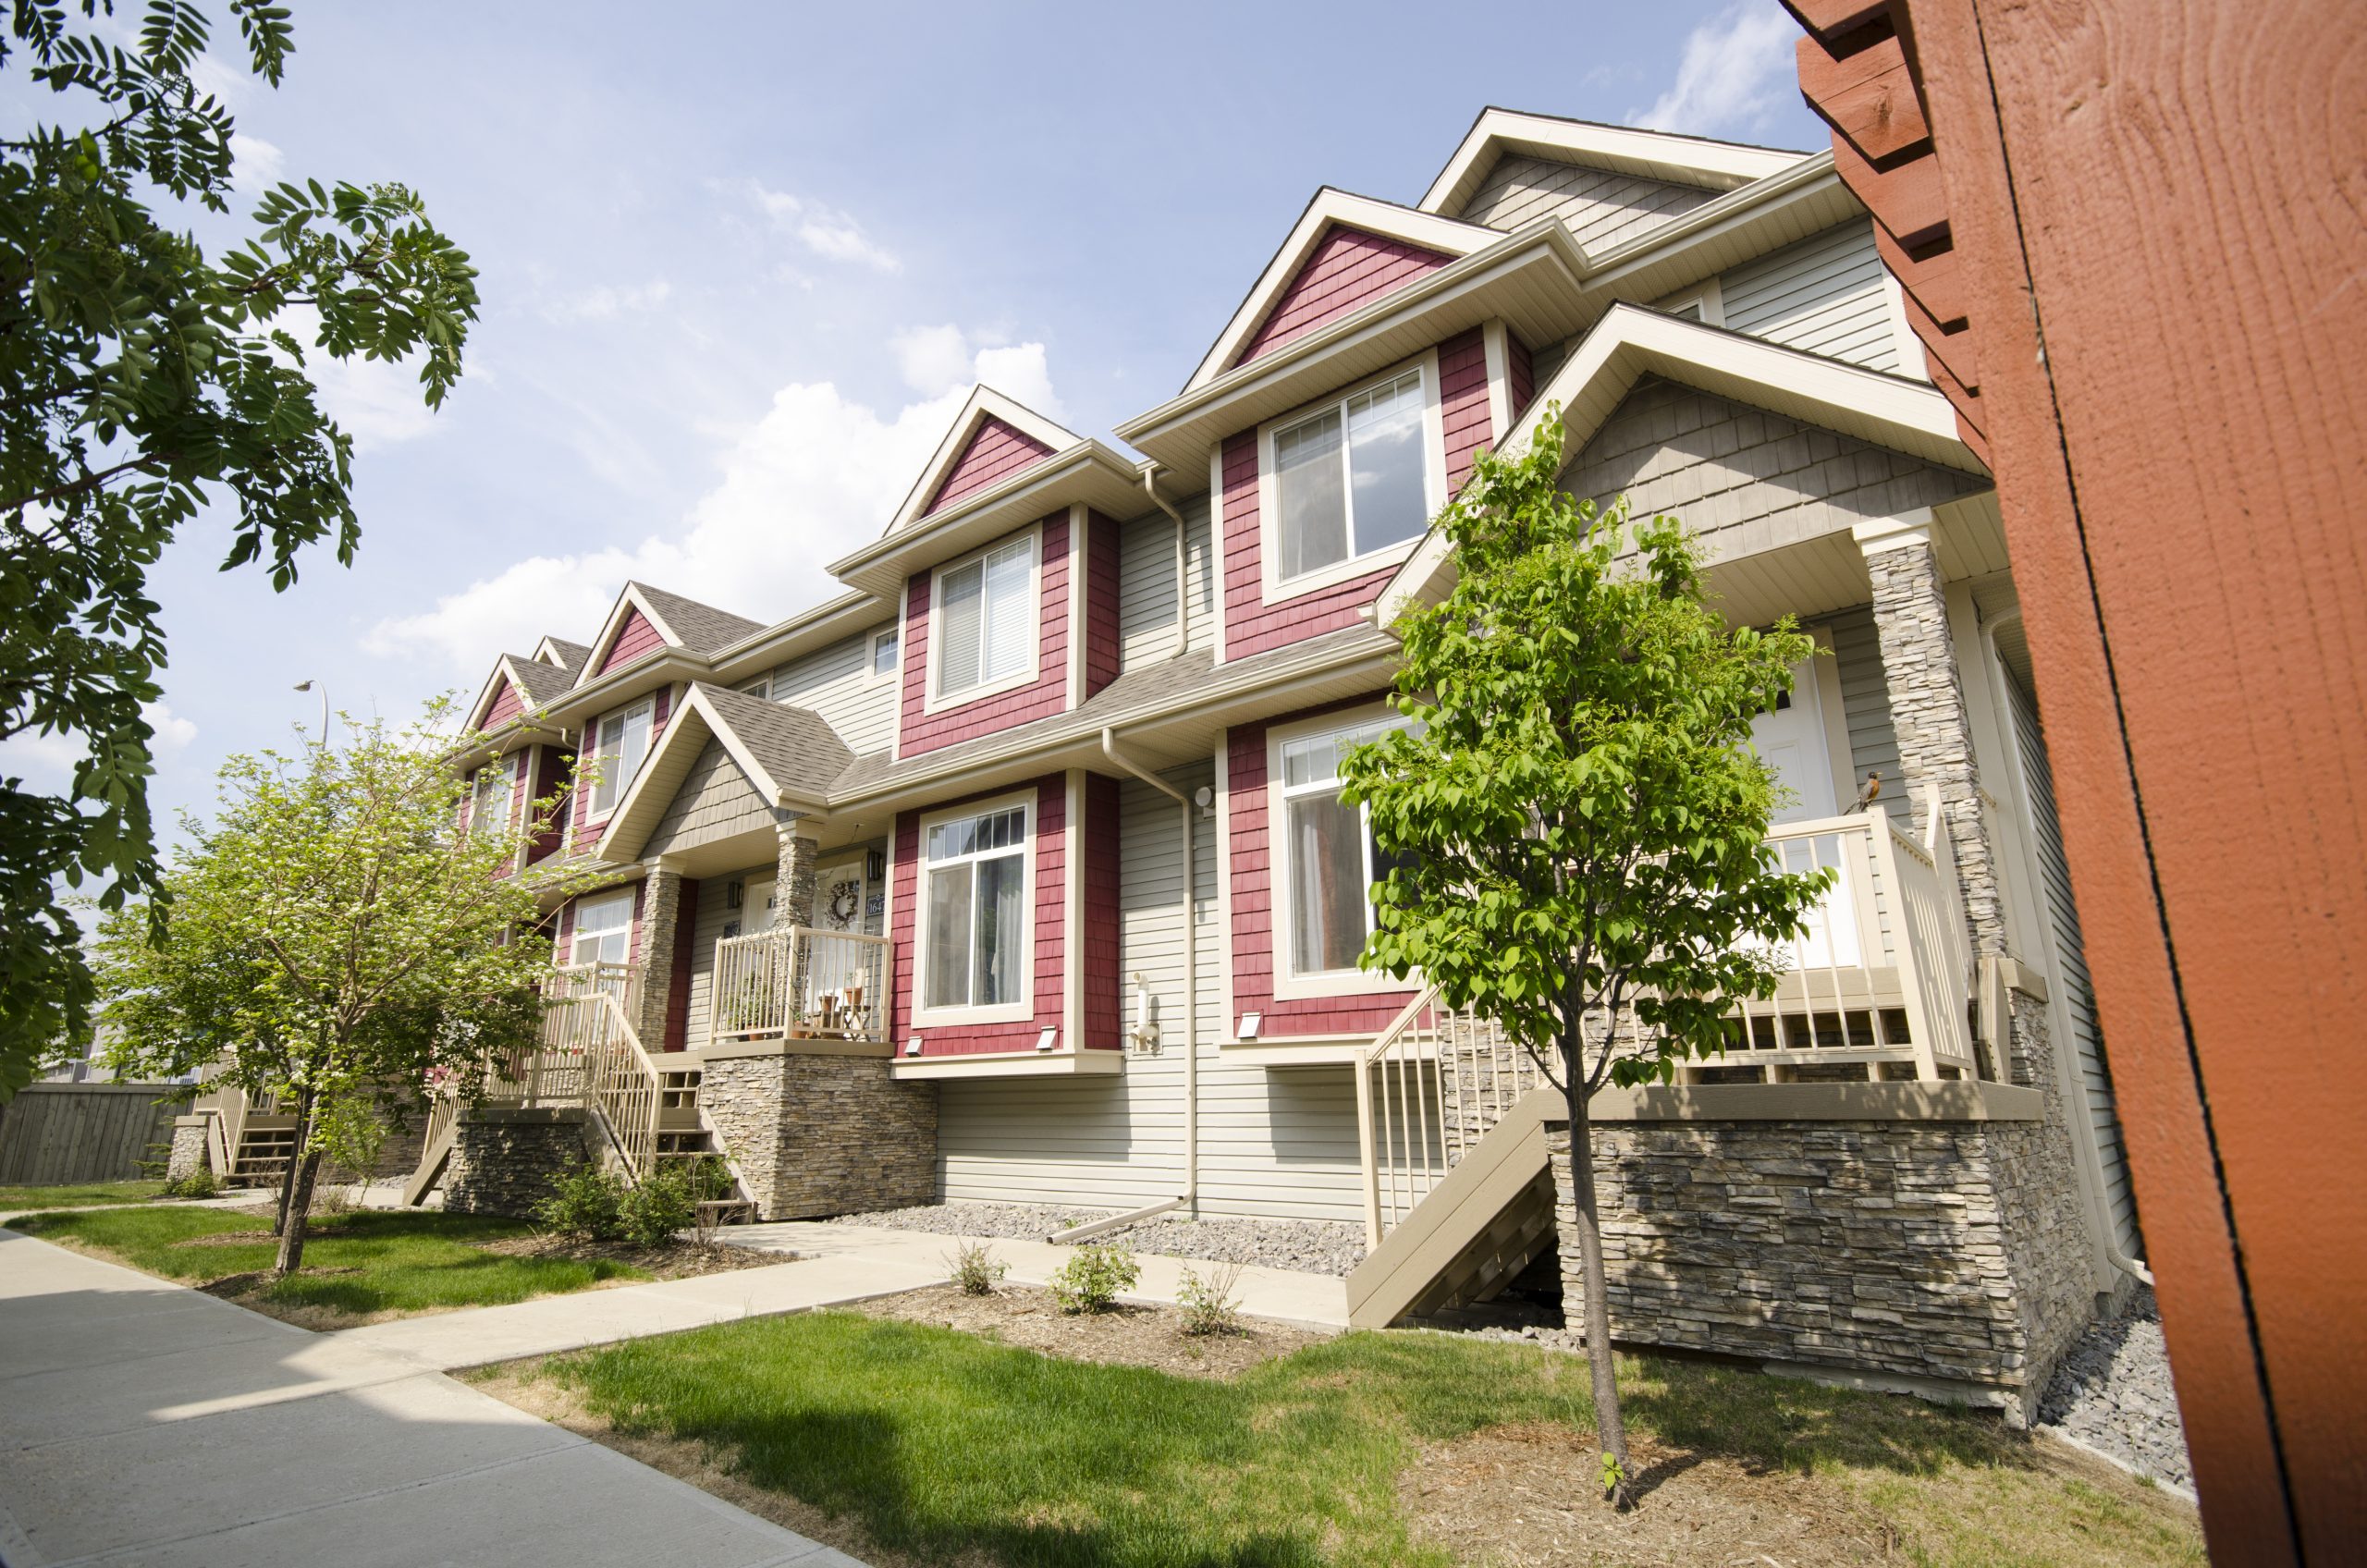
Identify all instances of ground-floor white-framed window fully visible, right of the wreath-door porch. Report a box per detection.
[921,805,1030,1009]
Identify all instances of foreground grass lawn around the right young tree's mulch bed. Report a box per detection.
[530,1312,2203,1568]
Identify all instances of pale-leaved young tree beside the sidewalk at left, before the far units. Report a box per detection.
[100,704,570,1269]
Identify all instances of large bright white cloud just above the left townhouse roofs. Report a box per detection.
[364,334,1058,684]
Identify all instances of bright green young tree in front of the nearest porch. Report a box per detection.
[1343,417,1827,1504]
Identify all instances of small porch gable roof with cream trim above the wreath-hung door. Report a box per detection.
[595,680,854,860]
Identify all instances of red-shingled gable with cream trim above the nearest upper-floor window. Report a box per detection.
[1184,185,1498,391]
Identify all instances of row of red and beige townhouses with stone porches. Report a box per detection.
[398,109,2142,1412]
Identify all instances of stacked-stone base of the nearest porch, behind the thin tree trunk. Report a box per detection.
[1548,1094,2095,1424]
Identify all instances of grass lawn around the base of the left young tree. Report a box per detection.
[9,1208,648,1327]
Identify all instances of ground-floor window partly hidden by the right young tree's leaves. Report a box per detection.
[1281,717,1406,978]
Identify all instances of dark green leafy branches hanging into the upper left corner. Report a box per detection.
[0,0,478,1106]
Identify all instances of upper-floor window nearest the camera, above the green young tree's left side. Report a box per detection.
[1261,365,1441,596]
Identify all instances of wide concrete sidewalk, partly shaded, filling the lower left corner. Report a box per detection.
[0,1231,859,1568]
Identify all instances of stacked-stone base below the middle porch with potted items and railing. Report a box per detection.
[698,1042,938,1219]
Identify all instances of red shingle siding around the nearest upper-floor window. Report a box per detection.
[1224,327,1489,658]
